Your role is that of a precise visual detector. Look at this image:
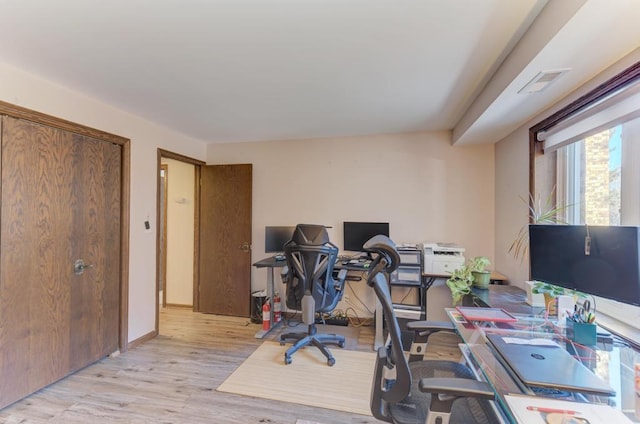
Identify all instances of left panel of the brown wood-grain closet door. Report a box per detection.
[0,117,73,405]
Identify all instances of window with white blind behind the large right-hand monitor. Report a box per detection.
[530,63,640,343]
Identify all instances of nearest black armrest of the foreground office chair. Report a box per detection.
[418,378,495,413]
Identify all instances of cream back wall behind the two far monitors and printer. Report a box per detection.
[207,132,494,313]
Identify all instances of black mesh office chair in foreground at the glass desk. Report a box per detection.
[364,235,499,424]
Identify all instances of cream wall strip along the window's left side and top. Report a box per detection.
[495,48,640,287]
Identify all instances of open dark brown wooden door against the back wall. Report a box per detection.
[198,164,252,317]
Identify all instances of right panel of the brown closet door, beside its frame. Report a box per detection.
[70,135,121,370]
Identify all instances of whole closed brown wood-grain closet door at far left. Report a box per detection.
[0,117,121,407]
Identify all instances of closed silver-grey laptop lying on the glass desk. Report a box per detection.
[487,334,616,396]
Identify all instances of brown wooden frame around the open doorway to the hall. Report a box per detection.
[155,148,206,334]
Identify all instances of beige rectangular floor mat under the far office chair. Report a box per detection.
[218,341,375,415]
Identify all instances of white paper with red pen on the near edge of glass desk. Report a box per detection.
[505,395,633,424]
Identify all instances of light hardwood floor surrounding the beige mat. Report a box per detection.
[0,309,378,424]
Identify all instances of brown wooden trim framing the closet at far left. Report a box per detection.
[0,101,131,352]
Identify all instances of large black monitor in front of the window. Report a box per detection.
[529,225,640,305]
